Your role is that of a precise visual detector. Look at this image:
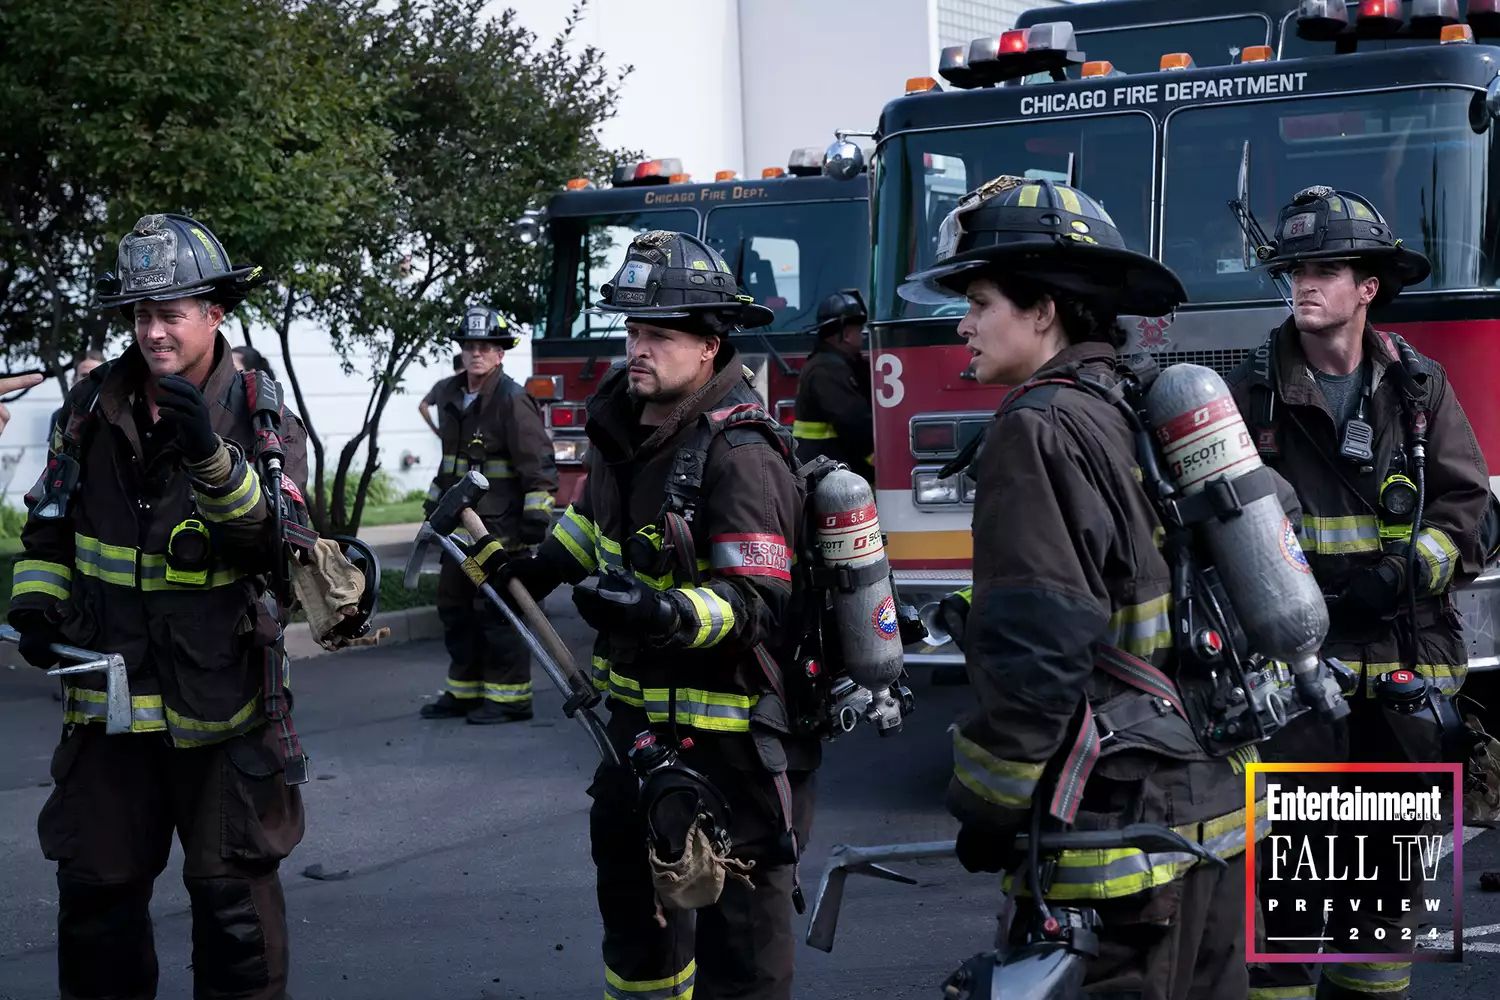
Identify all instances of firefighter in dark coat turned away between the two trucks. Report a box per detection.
[792,288,875,484]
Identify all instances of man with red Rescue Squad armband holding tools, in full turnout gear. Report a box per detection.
[507,231,819,1000]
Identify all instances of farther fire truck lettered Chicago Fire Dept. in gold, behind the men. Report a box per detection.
[522,148,870,502]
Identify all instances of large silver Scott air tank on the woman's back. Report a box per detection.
[1146,364,1328,673]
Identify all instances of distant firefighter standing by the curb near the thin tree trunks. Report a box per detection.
[422,306,558,726]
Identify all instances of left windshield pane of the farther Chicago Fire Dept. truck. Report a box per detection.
[546,208,698,337]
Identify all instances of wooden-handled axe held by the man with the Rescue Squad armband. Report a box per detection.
[404,471,620,765]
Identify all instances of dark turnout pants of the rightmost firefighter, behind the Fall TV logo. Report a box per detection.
[1250,707,1451,1000]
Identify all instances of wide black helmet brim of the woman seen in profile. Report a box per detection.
[897,243,1188,316]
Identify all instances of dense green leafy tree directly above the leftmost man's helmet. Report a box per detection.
[0,0,392,389]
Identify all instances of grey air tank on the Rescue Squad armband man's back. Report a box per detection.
[813,468,903,693]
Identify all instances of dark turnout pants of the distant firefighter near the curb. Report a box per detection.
[438,562,531,709]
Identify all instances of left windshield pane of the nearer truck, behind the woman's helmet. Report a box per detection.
[873,114,1152,319]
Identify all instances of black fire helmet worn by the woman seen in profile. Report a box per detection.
[899,175,1188,316]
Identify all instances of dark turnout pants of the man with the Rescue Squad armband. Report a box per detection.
[588,706,813,1000]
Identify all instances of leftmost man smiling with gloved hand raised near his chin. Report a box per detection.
[9,214,306,1000]
